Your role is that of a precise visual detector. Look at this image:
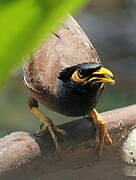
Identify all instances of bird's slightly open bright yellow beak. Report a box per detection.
[89,67,115,84]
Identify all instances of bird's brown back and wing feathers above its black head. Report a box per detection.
[24,16,100,91]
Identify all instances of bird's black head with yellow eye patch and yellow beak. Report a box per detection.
[59,62,115,90]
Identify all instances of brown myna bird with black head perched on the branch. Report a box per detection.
[23,15,115,159]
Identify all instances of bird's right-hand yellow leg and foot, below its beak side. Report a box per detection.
[89,109,112,157]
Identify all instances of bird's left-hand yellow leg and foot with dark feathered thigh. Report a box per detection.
[29,98,67,152]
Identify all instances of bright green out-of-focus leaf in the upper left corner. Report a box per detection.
[0,0,87,85]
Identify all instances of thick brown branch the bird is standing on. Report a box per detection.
[0,105,136,179]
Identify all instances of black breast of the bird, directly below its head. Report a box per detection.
[58,86,99,116]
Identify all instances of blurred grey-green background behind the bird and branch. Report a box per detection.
[0,0,136,137]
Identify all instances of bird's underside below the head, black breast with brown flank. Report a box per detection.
[31,81,100,116]
